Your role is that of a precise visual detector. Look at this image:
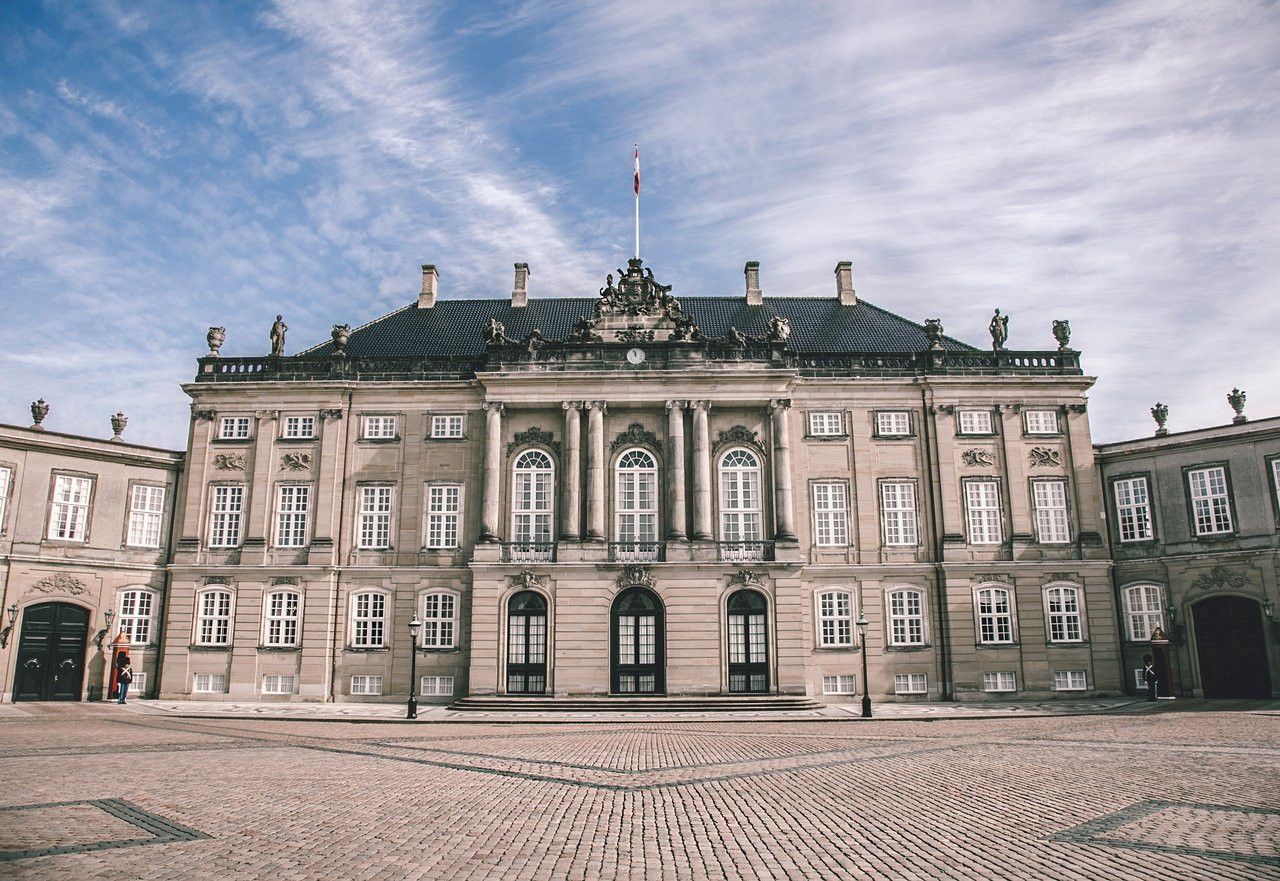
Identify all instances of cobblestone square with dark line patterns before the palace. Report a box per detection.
[0,703,1280,881]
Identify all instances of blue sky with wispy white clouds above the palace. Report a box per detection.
[0,0,1280,448]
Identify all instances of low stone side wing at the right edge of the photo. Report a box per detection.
[1098,417,1280,697]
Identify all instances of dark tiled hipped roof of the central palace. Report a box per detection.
[305,297,975,357]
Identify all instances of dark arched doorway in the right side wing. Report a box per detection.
[1193,597,1271,698]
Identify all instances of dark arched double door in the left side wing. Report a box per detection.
[13,603,88,700]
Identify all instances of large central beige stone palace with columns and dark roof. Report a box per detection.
[147,259,1126,702]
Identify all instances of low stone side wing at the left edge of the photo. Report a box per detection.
[0,422,183,700]
